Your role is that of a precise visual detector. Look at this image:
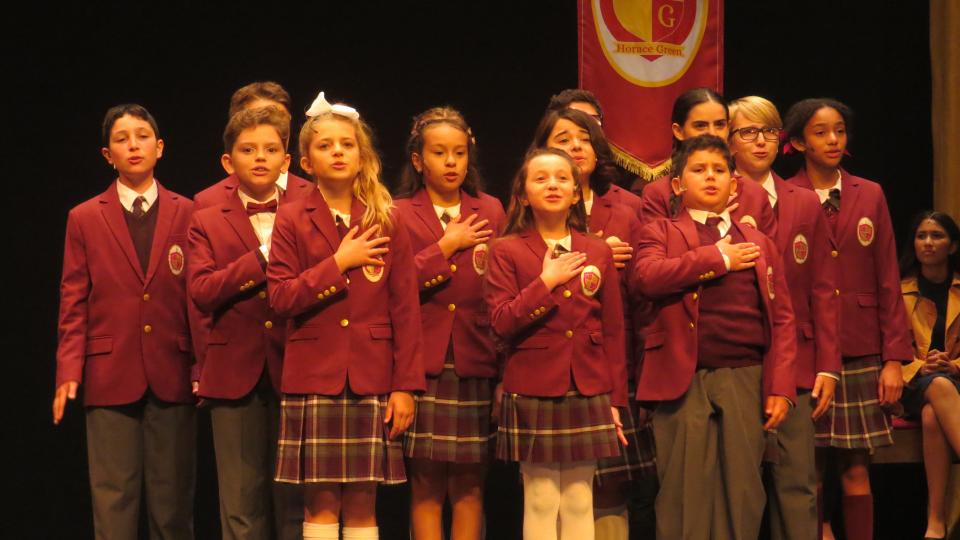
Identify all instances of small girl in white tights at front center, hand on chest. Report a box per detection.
[485,149,628,540]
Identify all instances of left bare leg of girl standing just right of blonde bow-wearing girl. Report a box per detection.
[409,459,447,540]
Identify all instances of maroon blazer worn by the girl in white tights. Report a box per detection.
[485,229,627,407]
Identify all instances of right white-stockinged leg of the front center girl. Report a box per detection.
[560,461,597,540]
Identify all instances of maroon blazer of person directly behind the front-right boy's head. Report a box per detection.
[640,175,777,238]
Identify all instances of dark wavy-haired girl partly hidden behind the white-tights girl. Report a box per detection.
[533,108,657,540]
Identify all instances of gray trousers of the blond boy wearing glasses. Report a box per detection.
[764,390,818,540]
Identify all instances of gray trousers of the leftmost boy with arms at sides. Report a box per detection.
[85,394,197,540]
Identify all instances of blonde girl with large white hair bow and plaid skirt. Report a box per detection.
[267,93,425,539]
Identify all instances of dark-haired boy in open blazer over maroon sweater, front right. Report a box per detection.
[634,135,796,539]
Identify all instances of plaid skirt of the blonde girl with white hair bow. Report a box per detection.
[275,389,407,484]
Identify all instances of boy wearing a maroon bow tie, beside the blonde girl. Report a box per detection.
[188,106,308,539]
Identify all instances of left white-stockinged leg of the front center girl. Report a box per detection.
[520,462,560,540]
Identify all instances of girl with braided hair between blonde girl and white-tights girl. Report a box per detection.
[396,107,504,540]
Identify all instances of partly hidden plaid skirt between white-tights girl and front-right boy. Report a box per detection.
[594,390,657,486]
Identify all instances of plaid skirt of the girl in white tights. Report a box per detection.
[497,390,620,463]
